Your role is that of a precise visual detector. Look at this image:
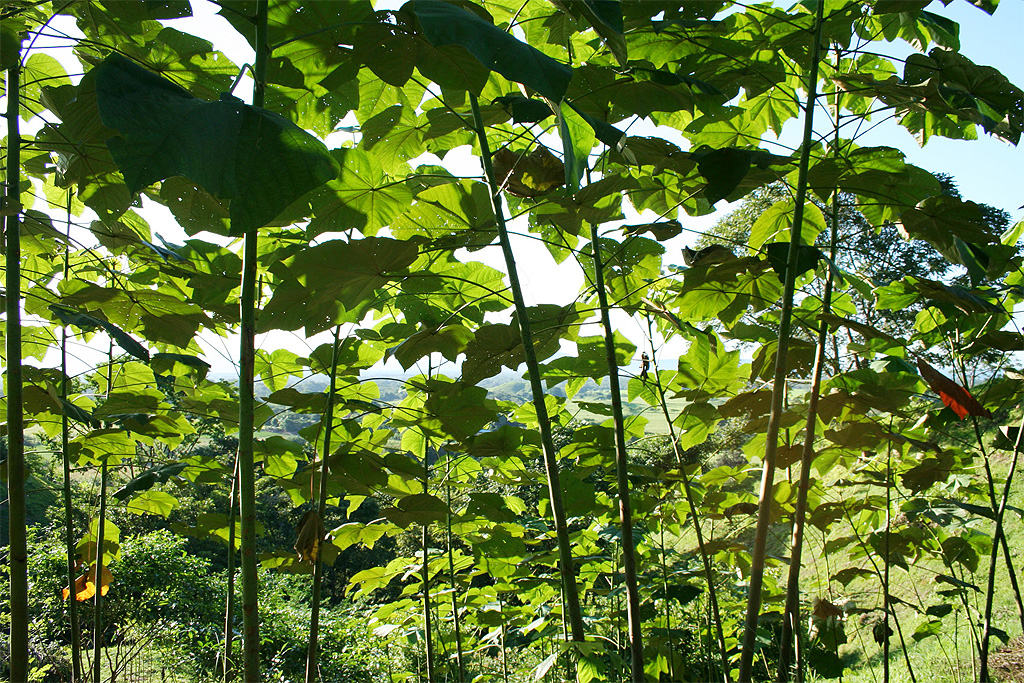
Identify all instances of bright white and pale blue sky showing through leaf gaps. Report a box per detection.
[19,0,1024,374]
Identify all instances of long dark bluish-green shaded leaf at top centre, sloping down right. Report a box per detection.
[401,0,572,102]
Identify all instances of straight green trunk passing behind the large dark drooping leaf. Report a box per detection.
[239,0,269,683]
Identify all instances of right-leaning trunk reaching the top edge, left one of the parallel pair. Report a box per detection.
[739,2,824,683]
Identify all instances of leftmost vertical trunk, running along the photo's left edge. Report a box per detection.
[3,57,29,681]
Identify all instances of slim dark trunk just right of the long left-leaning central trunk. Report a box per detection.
[591,231,644,683]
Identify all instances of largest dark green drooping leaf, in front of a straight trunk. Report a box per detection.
[96,53,338,234]
